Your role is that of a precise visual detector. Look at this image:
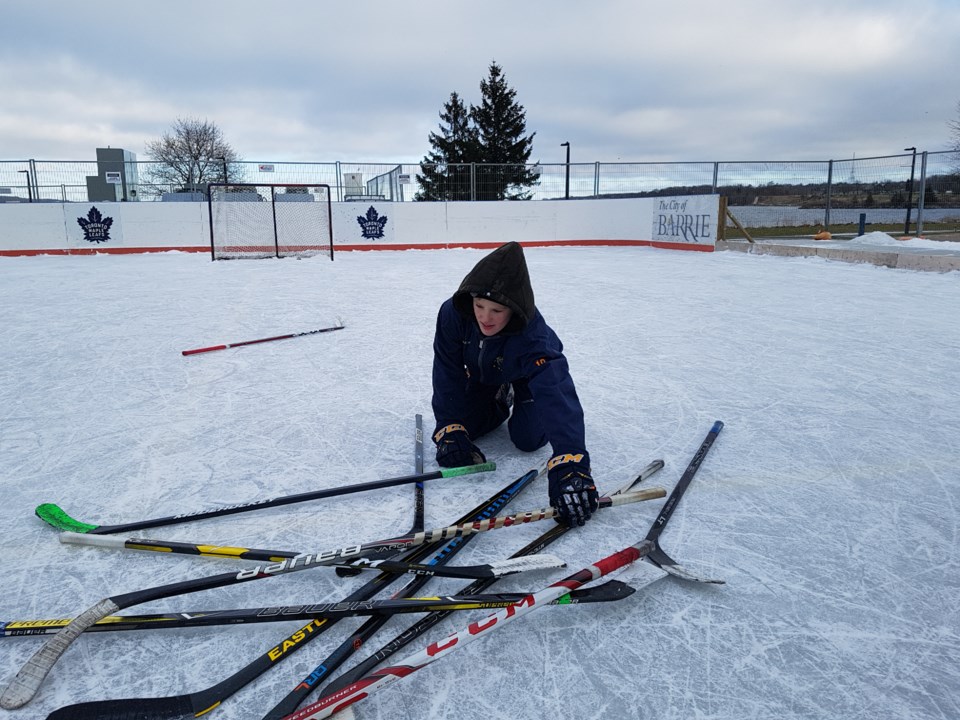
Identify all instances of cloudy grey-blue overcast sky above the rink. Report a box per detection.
[0,0,960,163]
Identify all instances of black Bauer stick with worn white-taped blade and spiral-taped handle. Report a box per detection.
[0,488,666,710]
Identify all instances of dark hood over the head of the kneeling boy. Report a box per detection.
[453,242,536,333]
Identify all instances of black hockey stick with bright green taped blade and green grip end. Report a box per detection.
[35,462,497,535]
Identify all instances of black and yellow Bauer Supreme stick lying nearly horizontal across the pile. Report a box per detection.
[0,580,634,637]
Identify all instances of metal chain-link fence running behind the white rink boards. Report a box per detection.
[0,151,960,234]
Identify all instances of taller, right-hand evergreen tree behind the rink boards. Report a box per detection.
[470,62,539,200]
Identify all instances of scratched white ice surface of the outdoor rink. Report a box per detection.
[0,248,960,720]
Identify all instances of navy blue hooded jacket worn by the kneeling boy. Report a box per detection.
[433,242,586,455]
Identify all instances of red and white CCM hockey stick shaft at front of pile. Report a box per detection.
[283,540,653,720]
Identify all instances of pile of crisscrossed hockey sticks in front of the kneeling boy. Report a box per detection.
[0,416,722,720]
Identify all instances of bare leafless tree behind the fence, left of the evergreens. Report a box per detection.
[144,118,240,197]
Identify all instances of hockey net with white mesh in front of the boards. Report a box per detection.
[208,183,333,260]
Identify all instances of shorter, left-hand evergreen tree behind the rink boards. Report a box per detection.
[414,92,478,200]
